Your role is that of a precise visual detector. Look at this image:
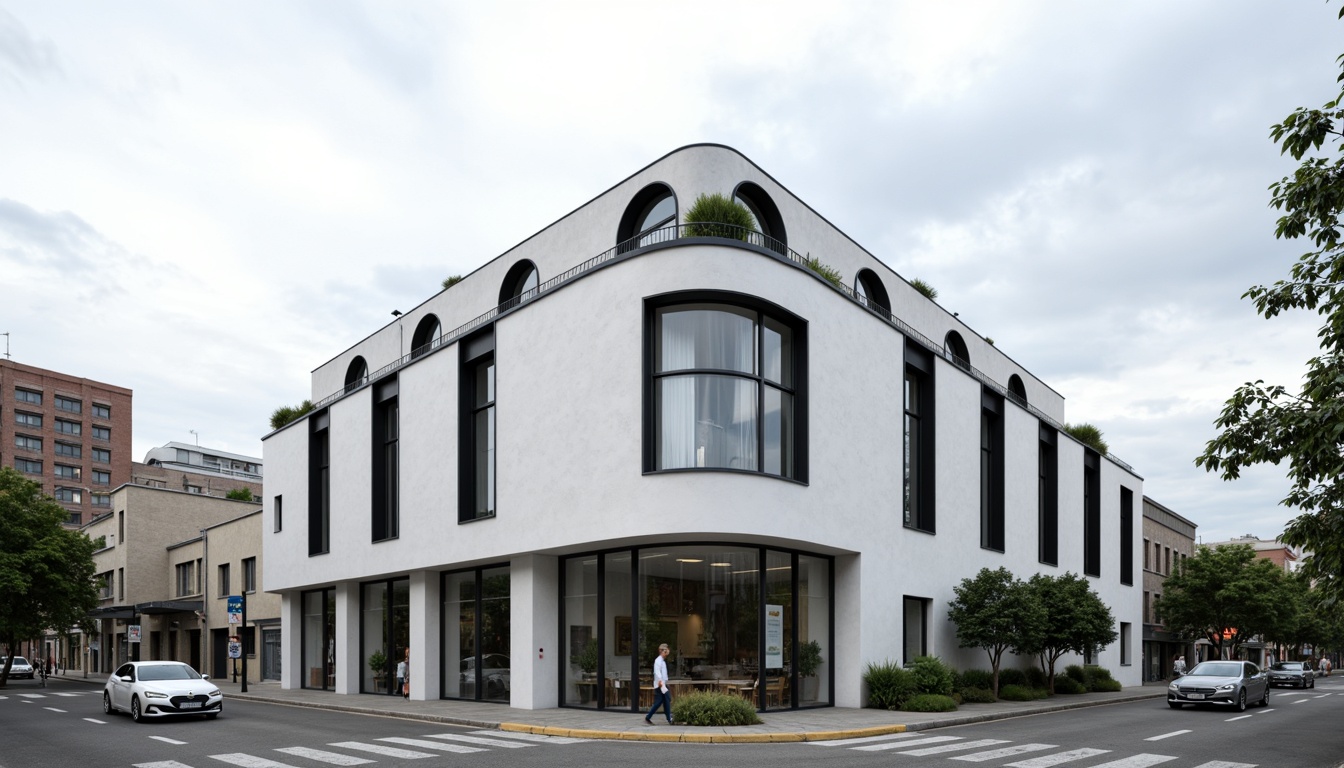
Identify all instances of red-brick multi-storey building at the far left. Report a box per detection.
[0,360,132,527]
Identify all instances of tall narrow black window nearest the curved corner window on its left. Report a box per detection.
[458,332,496,522]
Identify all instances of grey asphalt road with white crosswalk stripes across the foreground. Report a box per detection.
[0,677,1344,768]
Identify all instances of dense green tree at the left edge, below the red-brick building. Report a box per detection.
[0,467,98,687]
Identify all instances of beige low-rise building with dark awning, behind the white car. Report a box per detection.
[79,483,264,673]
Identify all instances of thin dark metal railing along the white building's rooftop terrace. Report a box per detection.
[313,223,1134,472]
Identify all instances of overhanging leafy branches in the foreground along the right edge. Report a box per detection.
[1195,8,1344,603]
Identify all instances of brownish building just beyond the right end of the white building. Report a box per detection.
[1144,496,1208,681]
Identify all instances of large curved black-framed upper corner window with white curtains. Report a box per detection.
[646,293,806,482]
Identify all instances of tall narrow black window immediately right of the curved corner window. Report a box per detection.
[902,342,937,533]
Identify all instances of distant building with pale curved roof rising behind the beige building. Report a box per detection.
[130,443,262,500]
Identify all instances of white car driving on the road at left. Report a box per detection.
[102,662,224,722]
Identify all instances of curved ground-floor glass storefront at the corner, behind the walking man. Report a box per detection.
[560,545,833,710]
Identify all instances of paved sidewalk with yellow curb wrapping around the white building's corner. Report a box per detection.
[47,675,1167,744]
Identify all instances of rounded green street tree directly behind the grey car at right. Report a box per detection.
[1157,545,1285,659]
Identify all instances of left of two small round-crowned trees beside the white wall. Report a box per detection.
[948,568,1046,697]
